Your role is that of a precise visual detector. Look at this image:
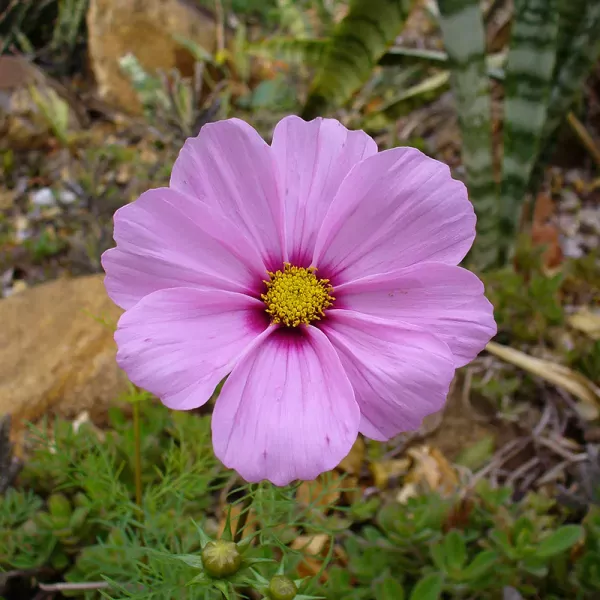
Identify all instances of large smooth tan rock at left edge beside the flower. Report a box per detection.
[0,275,127,442]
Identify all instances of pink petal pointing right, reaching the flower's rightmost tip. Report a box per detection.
[335,263,496,367]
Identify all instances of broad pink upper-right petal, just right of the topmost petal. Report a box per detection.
[313,148,475,283]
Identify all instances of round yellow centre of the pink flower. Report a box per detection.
[261,263,335,327]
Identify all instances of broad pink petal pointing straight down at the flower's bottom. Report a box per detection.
[212,327,360,485]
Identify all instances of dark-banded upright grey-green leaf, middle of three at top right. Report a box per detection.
[500,0,558,239]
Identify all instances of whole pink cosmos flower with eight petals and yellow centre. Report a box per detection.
[102,117,496,485]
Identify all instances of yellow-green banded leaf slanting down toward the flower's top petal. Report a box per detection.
[302,0,412,119]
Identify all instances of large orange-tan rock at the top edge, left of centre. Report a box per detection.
[87,0,217,114]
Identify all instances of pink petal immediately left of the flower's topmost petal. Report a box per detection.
[170,119,285,269]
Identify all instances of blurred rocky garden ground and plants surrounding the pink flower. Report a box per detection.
[0,0,600,600]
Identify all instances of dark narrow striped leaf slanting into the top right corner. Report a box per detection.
[529,0,600,191]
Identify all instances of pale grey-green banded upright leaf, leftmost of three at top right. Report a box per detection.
[438,0,500,264]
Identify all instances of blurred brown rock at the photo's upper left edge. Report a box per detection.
[0,56,86,150]
